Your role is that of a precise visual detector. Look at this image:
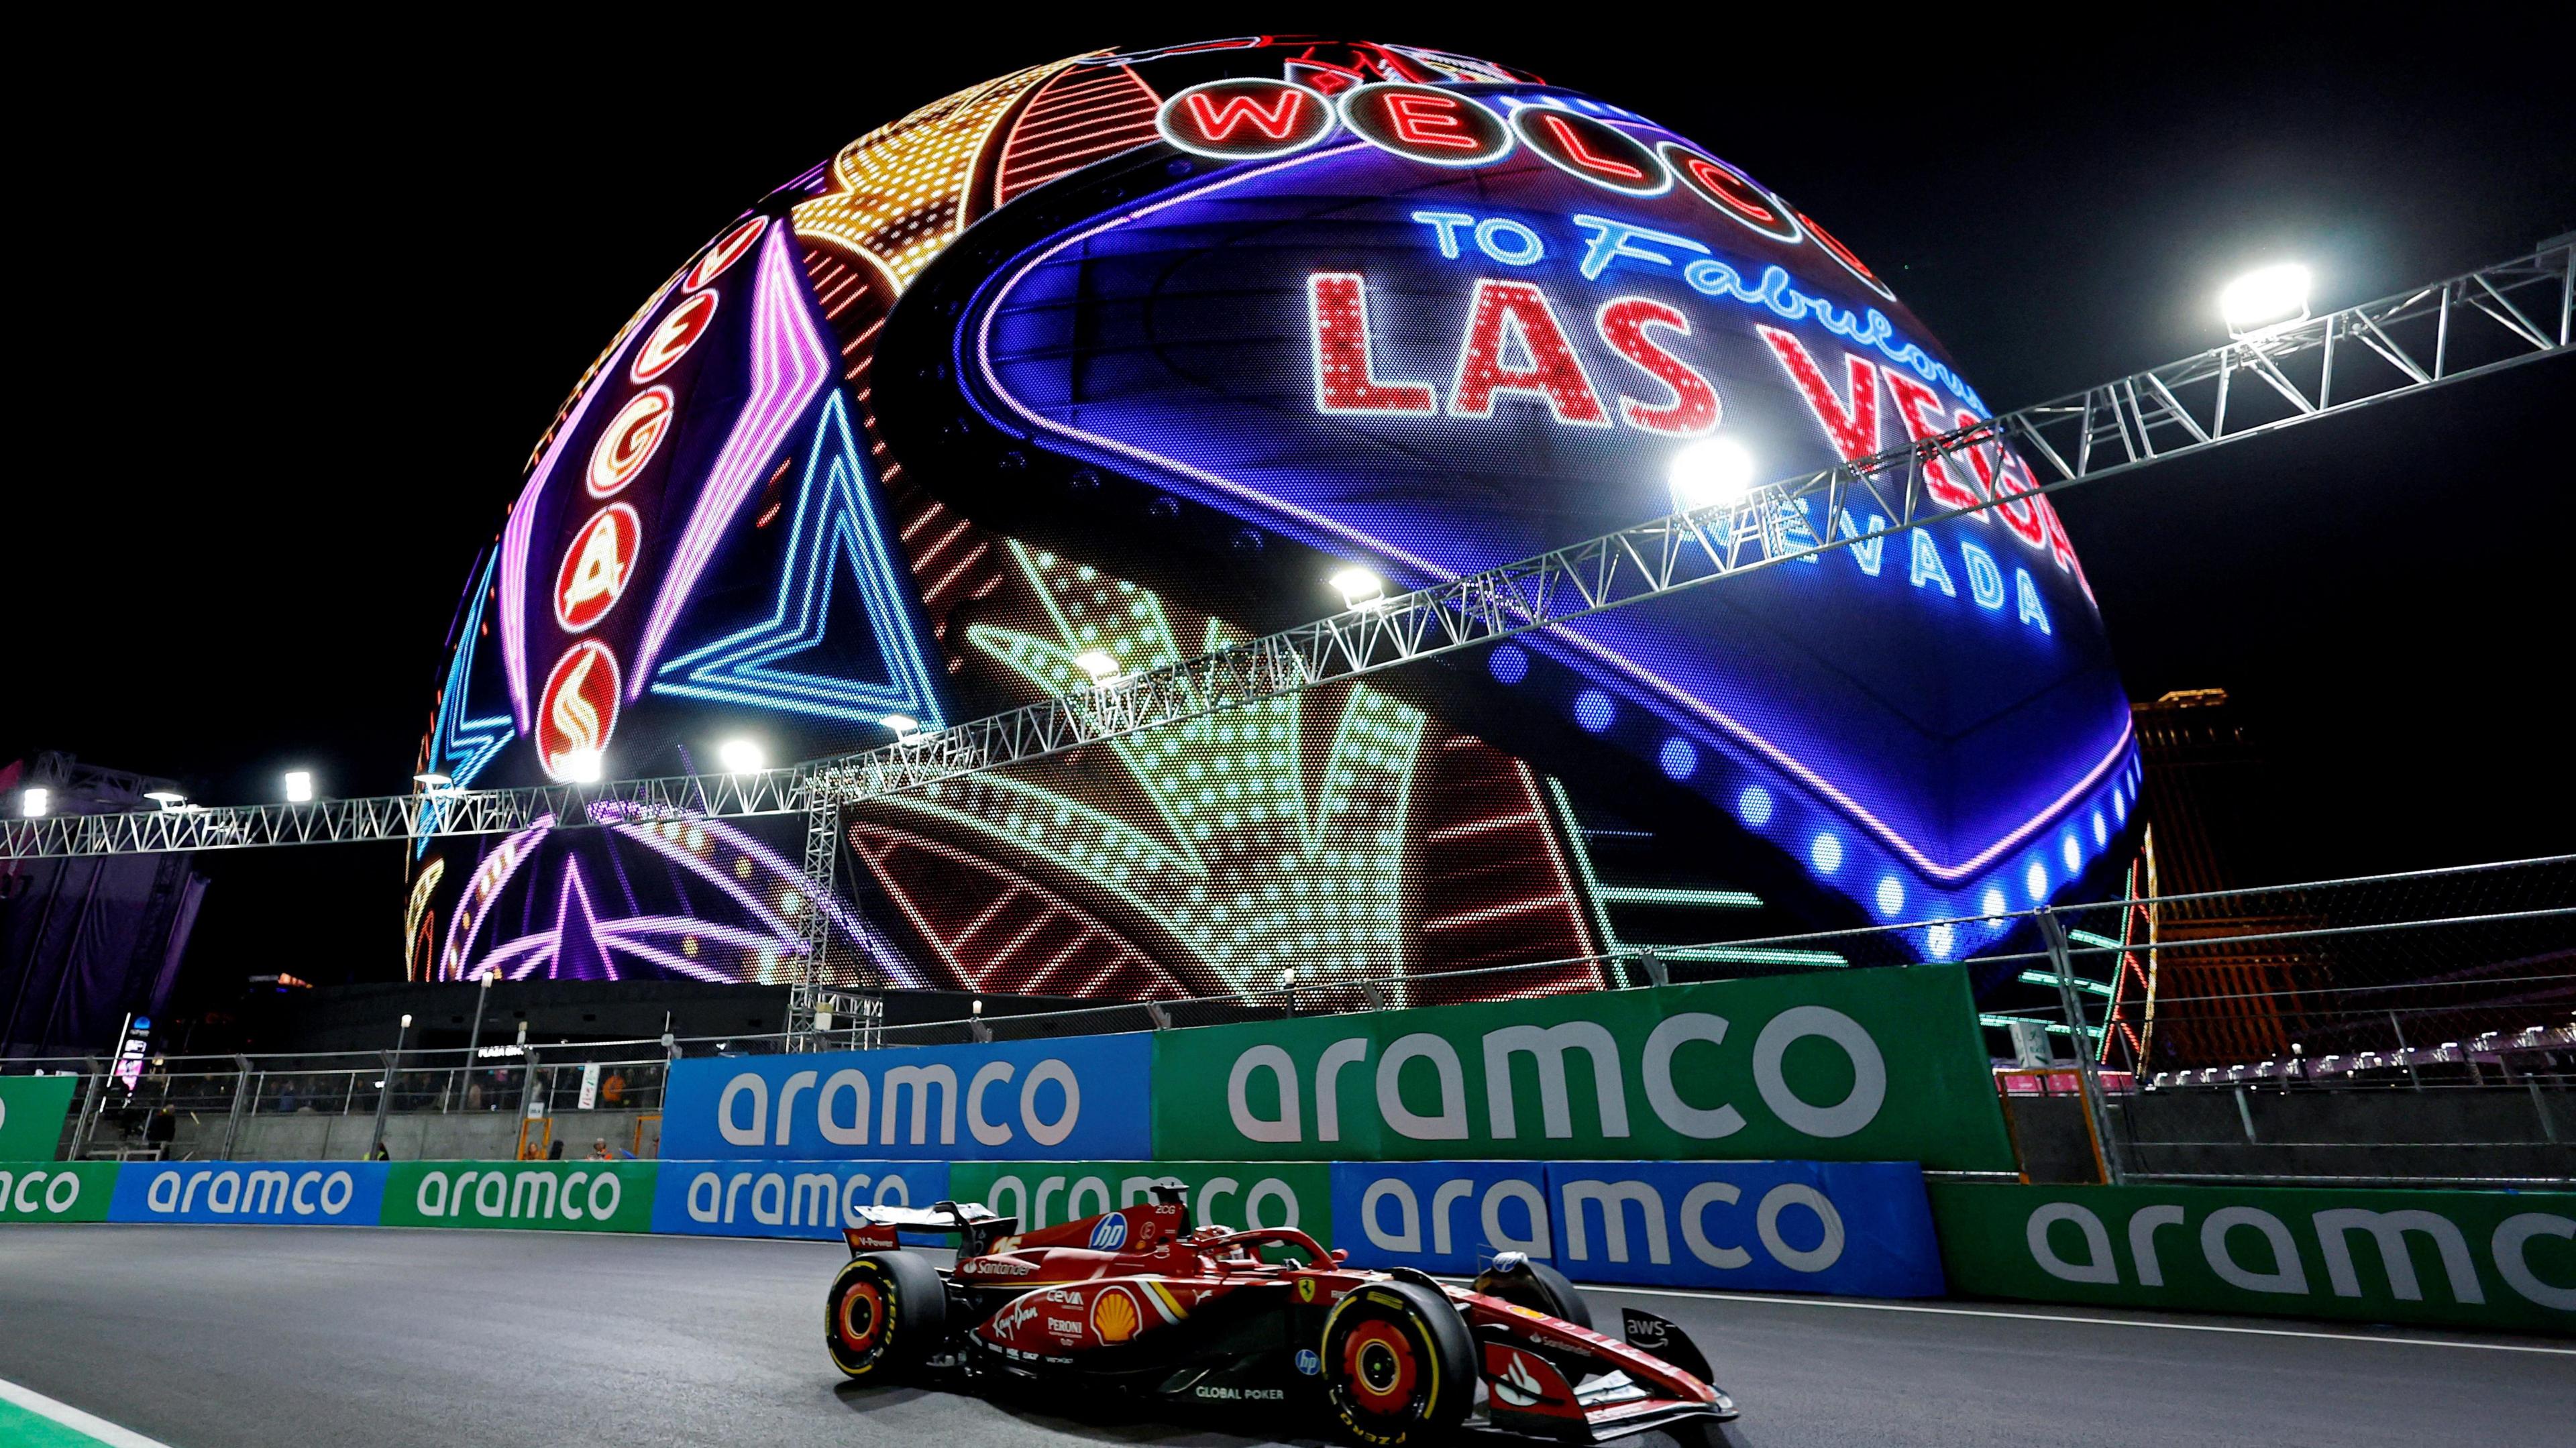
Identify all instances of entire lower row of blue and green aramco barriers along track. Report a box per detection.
[0,1160,2576,1337]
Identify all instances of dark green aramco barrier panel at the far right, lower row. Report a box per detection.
[1924,1182,2576,1335]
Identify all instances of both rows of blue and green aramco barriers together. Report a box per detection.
[0,966,2576,1335]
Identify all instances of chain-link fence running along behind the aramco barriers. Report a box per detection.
[0,855,2576,1180]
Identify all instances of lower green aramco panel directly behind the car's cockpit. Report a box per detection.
[948,1162,1332,1247]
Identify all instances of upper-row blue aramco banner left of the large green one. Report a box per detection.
[662,1033,1154,1162]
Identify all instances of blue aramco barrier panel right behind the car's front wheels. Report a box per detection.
[1332,1162,1945,1296]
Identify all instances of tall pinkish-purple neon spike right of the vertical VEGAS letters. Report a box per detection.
[626,227,832,698]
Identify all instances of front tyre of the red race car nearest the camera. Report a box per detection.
[1324,1283,1476,1448]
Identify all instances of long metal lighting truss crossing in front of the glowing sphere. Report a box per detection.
[0,237,2576,865]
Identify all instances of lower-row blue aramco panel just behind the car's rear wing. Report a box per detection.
[652,1162,956,1247]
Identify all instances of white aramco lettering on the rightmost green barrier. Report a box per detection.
[2025,1201,2576,1311]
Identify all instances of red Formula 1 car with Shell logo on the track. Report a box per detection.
[824,1188,1736,1448]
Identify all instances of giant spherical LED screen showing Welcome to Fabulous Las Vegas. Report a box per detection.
[410,36,2135,997]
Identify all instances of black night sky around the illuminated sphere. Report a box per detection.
[0,22,2576,985]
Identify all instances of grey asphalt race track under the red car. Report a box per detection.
[0,1227,2576,1448]
